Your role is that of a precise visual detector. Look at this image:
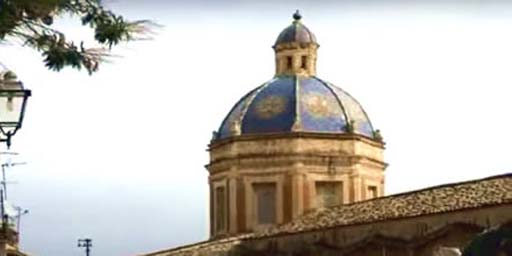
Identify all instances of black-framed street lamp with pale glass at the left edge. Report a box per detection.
[0,71,31,147]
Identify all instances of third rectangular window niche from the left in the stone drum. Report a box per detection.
[315,181,343,208]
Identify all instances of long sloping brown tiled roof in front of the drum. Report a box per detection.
[141,173,512,256]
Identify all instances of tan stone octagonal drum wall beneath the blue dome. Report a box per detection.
[207,133,386,237]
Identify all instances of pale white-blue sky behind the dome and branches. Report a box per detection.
[0,0,512,256]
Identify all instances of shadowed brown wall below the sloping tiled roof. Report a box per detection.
[232,204,512,256]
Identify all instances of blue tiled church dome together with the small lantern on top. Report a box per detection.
[213,12,380,140]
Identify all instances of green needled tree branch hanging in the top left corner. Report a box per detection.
[0,0,151,74]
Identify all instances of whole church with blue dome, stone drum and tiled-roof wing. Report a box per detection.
[140,12,512,256]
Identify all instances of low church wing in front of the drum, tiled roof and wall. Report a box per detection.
[139,174,512,256]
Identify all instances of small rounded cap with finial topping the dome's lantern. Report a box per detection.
[274,11,317,46]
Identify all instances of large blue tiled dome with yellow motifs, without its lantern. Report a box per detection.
[216,76,374,139]
